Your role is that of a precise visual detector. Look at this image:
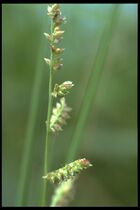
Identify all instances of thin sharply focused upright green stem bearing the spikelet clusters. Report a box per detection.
[41,20,53,206]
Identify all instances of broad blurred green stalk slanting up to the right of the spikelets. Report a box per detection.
[67,5,119,162]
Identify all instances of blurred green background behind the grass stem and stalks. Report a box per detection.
[2,4,137,206]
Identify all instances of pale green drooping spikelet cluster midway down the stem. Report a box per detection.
[50,97,72,132]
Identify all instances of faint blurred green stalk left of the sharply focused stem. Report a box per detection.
[16,13,45,206]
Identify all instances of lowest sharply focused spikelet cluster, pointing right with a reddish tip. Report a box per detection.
[42,158,92,184]
